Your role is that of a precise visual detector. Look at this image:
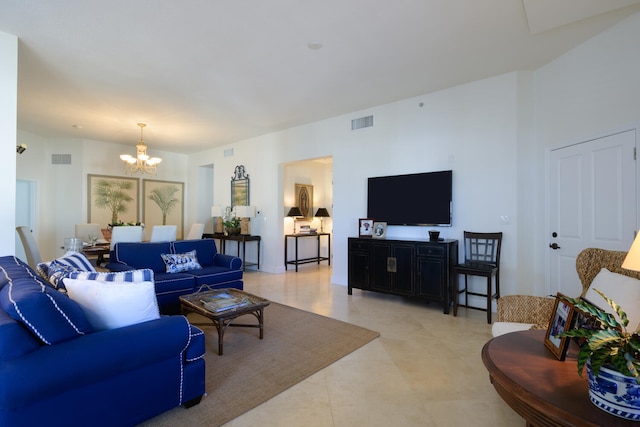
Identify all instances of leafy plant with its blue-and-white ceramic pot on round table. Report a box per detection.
[562,289,640,420]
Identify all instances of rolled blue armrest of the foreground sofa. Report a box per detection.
[0,316,191,407]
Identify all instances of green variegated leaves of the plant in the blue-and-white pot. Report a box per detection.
[561,289,640,384]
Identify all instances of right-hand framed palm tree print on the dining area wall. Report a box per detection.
[142,179,184,240]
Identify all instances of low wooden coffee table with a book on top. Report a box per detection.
[180,289,269,356]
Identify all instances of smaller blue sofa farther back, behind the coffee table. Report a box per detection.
[106,239,243,314]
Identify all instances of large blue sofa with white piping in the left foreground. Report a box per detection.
[0,256,205,427]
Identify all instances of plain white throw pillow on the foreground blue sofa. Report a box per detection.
[63,278,160,330]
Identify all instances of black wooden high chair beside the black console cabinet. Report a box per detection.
[453,231,502,323]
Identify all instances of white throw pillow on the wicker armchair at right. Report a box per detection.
[584,268,640,331]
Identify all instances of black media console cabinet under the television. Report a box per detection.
[348,237,458,314]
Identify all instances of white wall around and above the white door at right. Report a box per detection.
[534,13,640,294]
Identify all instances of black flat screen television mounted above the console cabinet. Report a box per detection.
[367,170,453,226]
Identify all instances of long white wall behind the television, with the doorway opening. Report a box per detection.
[191,73,519,304]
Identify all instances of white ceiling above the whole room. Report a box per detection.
[0,0,640,154]
